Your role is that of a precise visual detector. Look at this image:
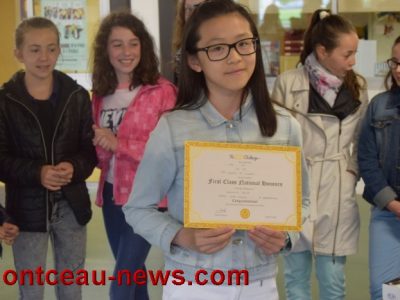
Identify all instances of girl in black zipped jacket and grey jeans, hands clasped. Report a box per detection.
[0,17,96,300]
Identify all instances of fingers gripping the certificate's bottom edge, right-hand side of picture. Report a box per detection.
[248,227,286,255]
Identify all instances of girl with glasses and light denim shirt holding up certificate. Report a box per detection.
[123,0,308,300]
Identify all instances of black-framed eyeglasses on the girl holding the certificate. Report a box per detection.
[196,37,258,61]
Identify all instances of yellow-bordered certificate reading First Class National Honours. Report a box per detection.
[184,141,302,231]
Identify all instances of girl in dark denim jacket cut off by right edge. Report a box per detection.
[358,36,400,300]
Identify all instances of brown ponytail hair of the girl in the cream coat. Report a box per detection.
[300,9,365,99]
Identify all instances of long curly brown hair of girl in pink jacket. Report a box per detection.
[92,12,160,96]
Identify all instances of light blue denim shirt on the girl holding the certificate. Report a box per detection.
[123,95,309,281]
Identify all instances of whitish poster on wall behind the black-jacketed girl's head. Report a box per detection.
[41,0,88,73]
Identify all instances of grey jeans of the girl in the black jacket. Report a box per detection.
[13,200,86,300]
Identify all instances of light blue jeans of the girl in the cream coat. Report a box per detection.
[284,251,346,300]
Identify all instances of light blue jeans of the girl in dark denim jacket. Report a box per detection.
[369,207,400,300]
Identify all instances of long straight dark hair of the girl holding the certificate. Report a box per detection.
[175,0,277,136]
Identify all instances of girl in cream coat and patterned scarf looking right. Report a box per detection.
[272,10,368,300]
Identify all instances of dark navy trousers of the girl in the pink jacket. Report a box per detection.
[103,182,150,300]
